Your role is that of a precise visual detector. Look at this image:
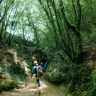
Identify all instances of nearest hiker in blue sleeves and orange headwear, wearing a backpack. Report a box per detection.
[32,61,42,87]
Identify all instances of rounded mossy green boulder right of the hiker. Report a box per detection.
[46,71,62,83]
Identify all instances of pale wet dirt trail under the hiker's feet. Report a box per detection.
[0,77,65,96]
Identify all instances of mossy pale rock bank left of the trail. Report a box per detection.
[0,49,30,92]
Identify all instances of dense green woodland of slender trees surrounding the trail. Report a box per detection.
[0,0,96,96]
